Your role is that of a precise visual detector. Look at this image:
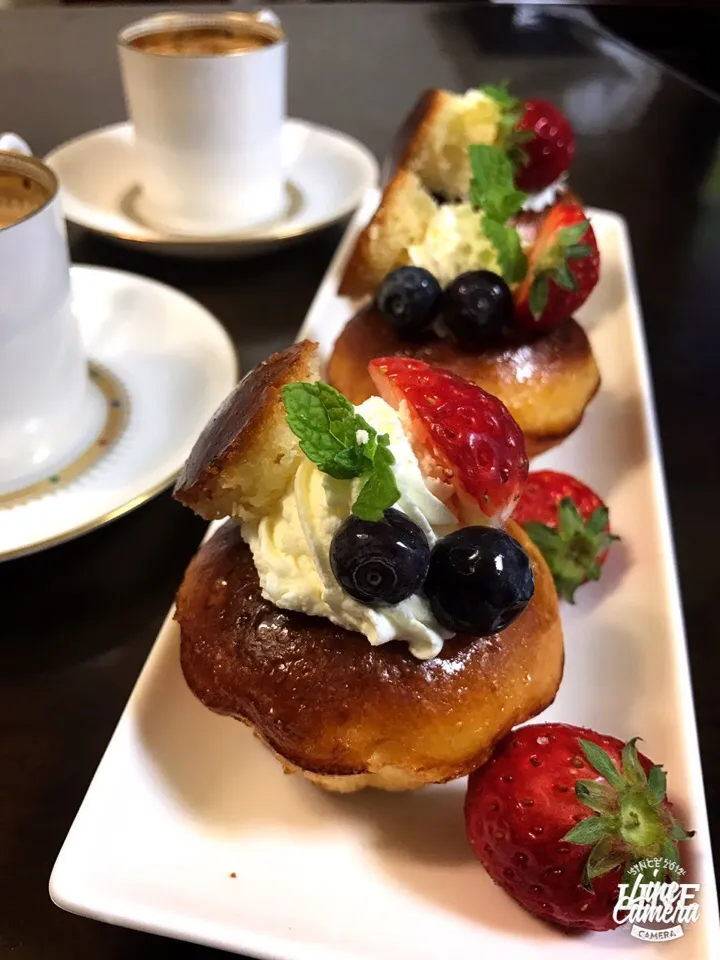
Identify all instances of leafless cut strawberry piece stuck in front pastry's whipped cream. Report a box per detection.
[369,357,528,524]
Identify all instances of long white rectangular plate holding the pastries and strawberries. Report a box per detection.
[50,195,720,960]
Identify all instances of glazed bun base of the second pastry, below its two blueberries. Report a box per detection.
[327,305,600,457]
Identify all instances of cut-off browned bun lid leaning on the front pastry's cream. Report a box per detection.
[173,340,319,520]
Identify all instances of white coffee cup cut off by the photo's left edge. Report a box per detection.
[0,134,89,494]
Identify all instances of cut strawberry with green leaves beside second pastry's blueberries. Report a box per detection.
[515,201,600,332]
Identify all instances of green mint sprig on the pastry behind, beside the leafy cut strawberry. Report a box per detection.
[468,144,527,284]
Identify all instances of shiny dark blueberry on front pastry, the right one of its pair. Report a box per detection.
[424,527,535,637]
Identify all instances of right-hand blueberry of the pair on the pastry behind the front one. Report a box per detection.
[442,270,513,346]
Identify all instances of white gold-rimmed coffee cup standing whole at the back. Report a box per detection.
[118,11,287,235]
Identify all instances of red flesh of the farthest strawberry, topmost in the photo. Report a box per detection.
[515,100,575,193]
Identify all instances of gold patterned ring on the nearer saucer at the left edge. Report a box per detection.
[0,363,130,510]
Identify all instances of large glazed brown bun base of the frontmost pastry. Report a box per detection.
[175,523,563,793]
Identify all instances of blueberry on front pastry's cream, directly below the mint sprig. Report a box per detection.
[330,510,430,605]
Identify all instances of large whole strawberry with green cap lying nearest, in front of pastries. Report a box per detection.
[465,723,692,930]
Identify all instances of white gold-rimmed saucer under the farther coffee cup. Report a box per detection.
[45,120,378,257]
